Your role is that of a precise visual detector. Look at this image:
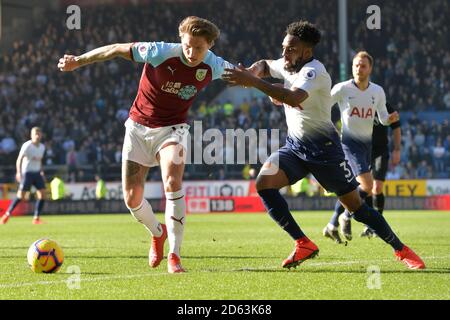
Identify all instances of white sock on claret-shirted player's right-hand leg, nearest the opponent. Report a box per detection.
[165,190,186,256]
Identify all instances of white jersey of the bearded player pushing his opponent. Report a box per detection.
[269,58,336,142]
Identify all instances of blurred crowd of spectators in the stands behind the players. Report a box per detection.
[0,0,450,182]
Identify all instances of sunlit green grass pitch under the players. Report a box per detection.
[0,211,450,300]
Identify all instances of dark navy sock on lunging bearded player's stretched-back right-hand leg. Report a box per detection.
[353,203,403,250]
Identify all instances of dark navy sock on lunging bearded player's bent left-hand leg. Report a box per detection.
[258,189,305,240]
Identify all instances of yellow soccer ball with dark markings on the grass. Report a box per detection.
[27,239,64,273]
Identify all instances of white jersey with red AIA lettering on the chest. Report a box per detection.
[331,79,389,143]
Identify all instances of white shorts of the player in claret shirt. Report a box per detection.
[122,118,190,167]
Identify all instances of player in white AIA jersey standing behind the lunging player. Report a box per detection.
[323,51,399,243]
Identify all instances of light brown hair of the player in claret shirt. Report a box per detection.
[178,16,220,43]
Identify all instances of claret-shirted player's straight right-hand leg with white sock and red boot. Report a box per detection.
[158,142,186,273]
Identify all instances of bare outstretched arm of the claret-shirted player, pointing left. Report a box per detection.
[58,43,132,71]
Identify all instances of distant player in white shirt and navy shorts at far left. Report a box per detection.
[0,127,45,224]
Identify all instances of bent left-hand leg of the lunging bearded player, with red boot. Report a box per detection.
[256,148,319,268]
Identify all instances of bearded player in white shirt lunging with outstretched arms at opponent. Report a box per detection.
[222,21,425,269]
